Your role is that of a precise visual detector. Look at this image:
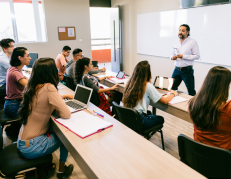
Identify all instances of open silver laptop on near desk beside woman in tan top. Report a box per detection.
[65,85,93,113]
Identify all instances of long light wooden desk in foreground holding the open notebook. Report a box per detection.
[52,84,204,179]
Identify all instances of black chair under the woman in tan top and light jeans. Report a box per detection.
[0,143,52,179]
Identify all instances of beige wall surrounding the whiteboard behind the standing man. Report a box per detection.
[112,0,231,94]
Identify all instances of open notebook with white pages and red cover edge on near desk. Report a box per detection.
[55,111,113,139]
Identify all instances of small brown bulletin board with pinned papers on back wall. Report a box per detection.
[58,27,76,40]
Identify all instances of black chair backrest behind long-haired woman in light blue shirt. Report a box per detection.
[112,101,143,133]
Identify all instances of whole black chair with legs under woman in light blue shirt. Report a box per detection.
[112,101,165,150]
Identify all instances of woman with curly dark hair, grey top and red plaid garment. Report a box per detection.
[74,57,118,115]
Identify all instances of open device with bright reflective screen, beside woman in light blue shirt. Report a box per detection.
[153,76,174,95]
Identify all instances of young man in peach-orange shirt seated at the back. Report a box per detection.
[55,46,71,80]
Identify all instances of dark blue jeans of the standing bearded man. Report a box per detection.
[172,66,196,96]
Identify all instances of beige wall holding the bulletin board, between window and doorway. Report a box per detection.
[16,0,92,59]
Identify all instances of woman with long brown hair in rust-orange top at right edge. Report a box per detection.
[189,66,231,150]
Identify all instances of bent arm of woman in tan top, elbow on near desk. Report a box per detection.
[47,84,71,119]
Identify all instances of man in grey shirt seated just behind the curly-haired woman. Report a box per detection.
[64,48,106,91]
